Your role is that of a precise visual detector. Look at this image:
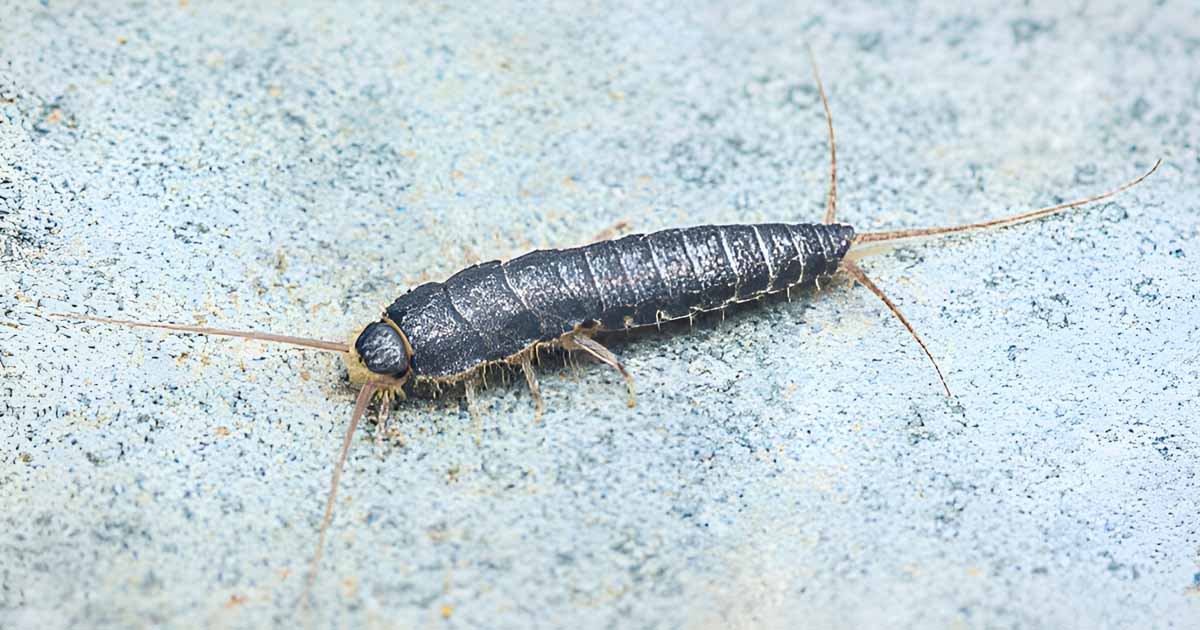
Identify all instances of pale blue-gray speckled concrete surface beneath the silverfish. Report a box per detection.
[0,0,1200,628]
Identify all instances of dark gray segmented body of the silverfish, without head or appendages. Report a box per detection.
[386,223,854,377]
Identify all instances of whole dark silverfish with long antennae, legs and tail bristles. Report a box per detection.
[56,55,1162,598]
